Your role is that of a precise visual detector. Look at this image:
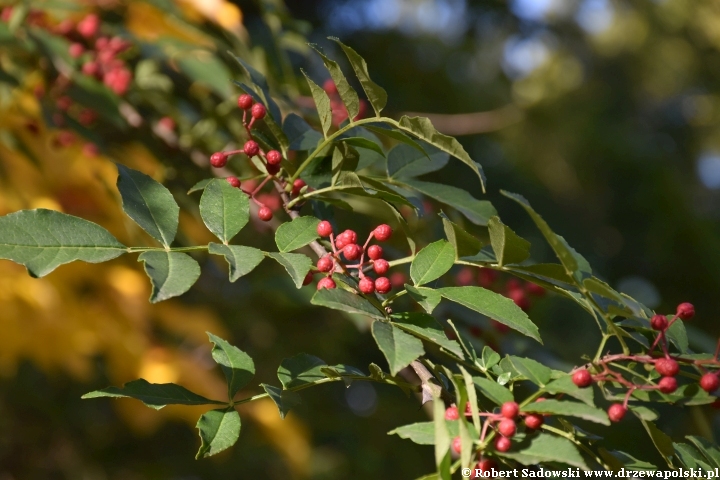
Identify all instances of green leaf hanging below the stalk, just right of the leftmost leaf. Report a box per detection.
[138,251,200,303]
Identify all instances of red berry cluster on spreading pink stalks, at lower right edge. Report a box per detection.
[572,303,720,422]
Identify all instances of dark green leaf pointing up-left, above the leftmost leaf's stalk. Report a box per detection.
[117,163,180,247]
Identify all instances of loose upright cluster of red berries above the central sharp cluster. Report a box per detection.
[210,94,307,222]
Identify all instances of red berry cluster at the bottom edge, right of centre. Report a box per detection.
[445,398,545,471]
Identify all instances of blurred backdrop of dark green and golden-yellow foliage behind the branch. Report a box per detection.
[0,0,720,479]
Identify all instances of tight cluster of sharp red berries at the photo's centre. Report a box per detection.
[305,220,393,295]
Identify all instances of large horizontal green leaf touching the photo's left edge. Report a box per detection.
[0,208,127,277]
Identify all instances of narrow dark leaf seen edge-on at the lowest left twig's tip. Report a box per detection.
[82,378,225,410]
